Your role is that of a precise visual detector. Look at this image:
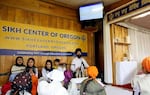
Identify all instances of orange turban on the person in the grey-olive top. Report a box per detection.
[87,66,98,79]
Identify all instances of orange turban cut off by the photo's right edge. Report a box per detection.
[142,57,150,72]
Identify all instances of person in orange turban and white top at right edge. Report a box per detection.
[131,57,150,95]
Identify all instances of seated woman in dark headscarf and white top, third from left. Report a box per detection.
[42,60,53,80]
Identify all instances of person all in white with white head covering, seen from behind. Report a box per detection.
[38,69,69,95]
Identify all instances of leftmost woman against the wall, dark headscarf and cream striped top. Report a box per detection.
[9,56,25,82]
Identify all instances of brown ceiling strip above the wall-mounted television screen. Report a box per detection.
[41,0,120,9]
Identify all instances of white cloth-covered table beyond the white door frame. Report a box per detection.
[116,61,137,85]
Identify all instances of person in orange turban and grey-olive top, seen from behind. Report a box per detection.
[80,66,106,95]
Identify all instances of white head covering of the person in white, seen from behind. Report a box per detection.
[47,69,65,81]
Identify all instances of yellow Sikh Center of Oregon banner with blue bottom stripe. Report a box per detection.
[0,20,87,56]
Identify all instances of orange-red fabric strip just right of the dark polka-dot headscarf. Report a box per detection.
[31,75,38,95]
